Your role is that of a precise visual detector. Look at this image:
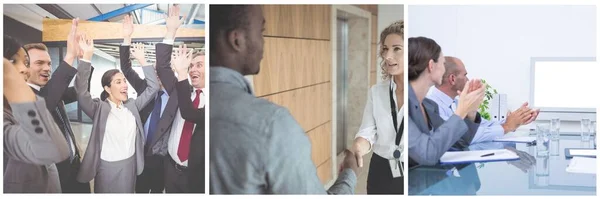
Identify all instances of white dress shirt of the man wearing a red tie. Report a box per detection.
[168,88,206,166]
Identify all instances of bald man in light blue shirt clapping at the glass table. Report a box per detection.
[427,56,539,144]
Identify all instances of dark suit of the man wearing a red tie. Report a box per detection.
[177,80,205,193]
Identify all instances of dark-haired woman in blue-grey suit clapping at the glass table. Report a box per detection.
[408,37,485,166]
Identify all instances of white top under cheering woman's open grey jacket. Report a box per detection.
[100,100,137,162]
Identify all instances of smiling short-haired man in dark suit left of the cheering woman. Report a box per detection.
[25,19,93,193]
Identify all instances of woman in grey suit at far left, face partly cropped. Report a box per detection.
[3,35,69,193]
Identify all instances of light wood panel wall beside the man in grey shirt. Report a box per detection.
[252,5,333,183]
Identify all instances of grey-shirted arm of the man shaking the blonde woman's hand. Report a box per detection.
[265,108,356,194]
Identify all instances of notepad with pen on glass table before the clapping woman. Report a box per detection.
[440,149,519,164]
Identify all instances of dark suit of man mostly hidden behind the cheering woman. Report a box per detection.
[119,46,167,193]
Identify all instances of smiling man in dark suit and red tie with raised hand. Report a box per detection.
[171,46,205,193]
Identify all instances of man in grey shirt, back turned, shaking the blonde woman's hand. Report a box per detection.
[209,5,358,194]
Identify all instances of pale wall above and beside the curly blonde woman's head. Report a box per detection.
[373,5,406,82]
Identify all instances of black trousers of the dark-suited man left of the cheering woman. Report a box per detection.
[56,154,91,193]
